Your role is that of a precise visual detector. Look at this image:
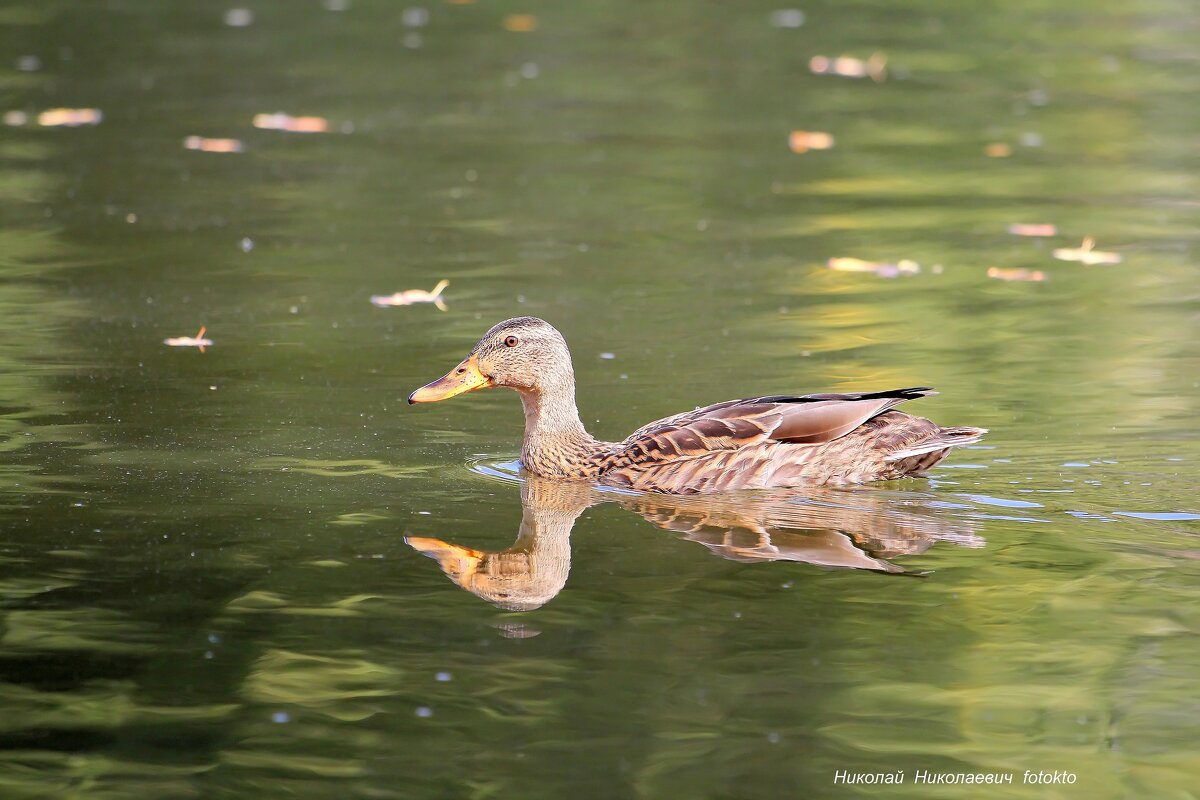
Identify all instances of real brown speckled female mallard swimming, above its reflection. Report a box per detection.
[408,317,986,494]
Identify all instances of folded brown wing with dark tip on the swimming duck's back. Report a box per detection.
[619,386,937,455]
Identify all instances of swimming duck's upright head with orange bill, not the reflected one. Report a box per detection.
[408,317,575,403]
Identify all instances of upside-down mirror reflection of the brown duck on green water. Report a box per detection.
[404,476,983,610]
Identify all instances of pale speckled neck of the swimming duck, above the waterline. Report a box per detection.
[520,377,601,477]
